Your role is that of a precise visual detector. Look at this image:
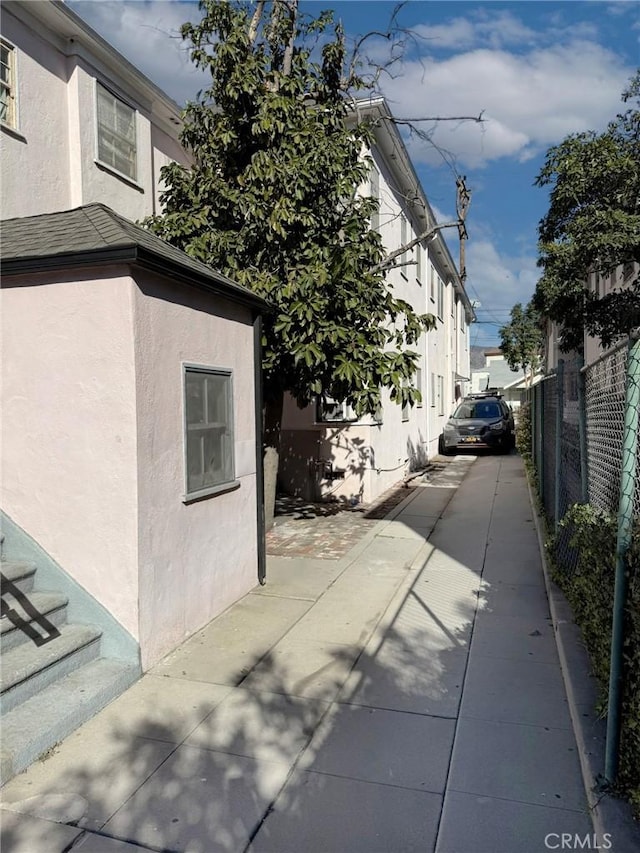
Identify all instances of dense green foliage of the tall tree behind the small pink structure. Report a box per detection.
[146,0,435,414]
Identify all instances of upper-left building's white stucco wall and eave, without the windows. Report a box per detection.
[1,7,187,221]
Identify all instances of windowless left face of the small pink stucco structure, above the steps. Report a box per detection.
[0,269,138,638]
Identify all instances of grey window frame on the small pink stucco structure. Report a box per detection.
[182,362,240,503]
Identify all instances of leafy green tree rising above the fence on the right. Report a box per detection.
[534,73,640,350]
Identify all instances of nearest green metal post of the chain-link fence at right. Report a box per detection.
[604,336,640,782]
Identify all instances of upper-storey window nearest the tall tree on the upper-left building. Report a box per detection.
[96,83,137,181]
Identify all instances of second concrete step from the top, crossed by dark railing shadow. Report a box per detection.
[0,592,69,652]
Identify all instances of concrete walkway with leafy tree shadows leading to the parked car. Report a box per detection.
[1,456,604,853]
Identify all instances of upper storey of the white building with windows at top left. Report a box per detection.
[0,0,187,221]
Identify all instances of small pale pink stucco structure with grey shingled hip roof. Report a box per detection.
[0,204,266,770]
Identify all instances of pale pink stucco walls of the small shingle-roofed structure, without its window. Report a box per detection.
[0,267,257,669]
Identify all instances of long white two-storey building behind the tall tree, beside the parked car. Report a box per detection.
[280,98,474,503]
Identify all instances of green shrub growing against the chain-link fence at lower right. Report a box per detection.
[555,504,640,816]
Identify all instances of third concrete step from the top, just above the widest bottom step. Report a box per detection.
[0,625,101,713]
